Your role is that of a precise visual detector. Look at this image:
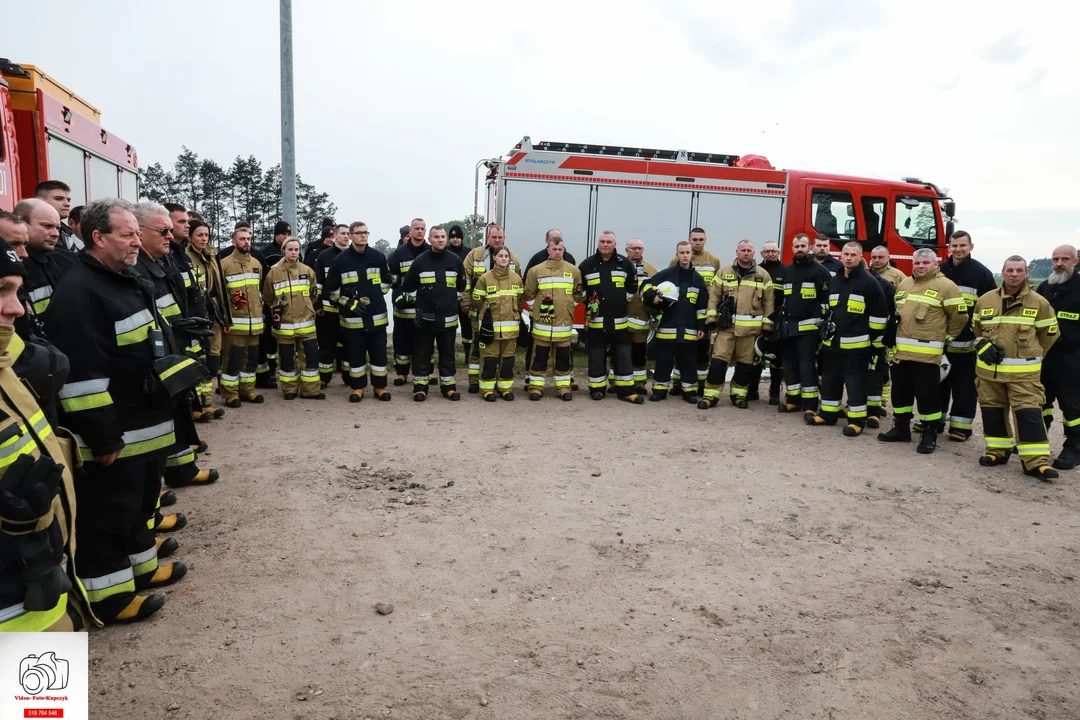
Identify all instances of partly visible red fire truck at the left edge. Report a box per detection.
[0,58,138,210]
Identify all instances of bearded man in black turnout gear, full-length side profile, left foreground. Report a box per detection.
[50,199,187,623]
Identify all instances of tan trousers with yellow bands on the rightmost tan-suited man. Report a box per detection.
[975,378,1050,470]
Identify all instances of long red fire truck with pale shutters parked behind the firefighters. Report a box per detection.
[474,137,956,273]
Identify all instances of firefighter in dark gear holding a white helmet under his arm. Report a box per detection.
[642,240,708,403]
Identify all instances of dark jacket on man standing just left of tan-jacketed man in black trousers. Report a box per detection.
[826,264,889,352]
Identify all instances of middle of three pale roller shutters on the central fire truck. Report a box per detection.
[596,186,691,268]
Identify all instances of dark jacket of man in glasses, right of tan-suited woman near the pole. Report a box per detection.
[320,245,390,330]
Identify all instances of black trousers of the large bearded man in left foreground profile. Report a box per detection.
[75,454,165,622]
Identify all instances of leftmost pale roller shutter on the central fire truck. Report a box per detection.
[499,179,591,267]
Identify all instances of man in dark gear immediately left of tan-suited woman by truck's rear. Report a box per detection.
[399,225,465,403]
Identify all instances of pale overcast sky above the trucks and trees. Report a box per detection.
[0,0,1080,264]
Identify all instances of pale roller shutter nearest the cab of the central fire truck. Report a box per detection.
[694,192,784,262]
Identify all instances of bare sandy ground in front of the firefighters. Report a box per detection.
[90,371,1080,720]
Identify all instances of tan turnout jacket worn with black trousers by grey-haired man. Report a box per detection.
[892,268,968,365]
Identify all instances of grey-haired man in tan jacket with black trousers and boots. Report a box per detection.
[878,247,968,454]
